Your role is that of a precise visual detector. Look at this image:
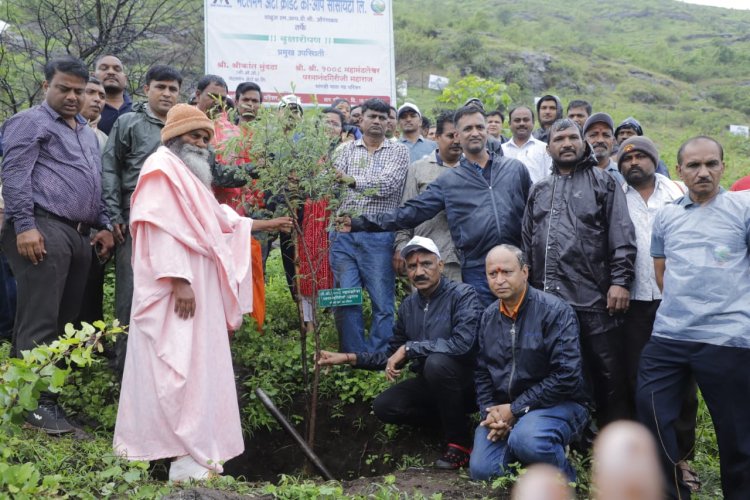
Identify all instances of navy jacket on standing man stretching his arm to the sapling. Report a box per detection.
[351,155,536,268]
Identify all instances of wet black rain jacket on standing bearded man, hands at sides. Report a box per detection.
[523,144,636,312]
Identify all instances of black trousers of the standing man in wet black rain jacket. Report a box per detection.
[576,311,628,429]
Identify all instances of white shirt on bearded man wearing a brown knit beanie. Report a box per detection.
[623,174,683,302]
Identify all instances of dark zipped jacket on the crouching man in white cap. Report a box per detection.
[357,278,482,373]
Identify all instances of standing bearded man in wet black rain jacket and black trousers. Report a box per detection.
[523,118,636,427]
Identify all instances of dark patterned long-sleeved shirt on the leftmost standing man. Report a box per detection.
[2,102,109,234]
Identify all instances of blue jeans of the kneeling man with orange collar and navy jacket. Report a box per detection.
[469,401,589,481]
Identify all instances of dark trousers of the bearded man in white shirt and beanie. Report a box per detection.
[622,300,698,459]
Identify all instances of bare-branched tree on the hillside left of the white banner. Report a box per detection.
[0,0,203,119]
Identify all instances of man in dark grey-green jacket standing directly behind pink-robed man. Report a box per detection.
[102,65,182,373]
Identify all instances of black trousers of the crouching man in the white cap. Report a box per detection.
[372,354,476,448]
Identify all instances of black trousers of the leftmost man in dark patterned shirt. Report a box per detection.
[2,217,91,356]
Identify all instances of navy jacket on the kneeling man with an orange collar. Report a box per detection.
[474,286,589,418]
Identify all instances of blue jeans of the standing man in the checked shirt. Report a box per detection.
[330,232,396,352]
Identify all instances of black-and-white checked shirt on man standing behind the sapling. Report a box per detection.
[334,139,409,215]
